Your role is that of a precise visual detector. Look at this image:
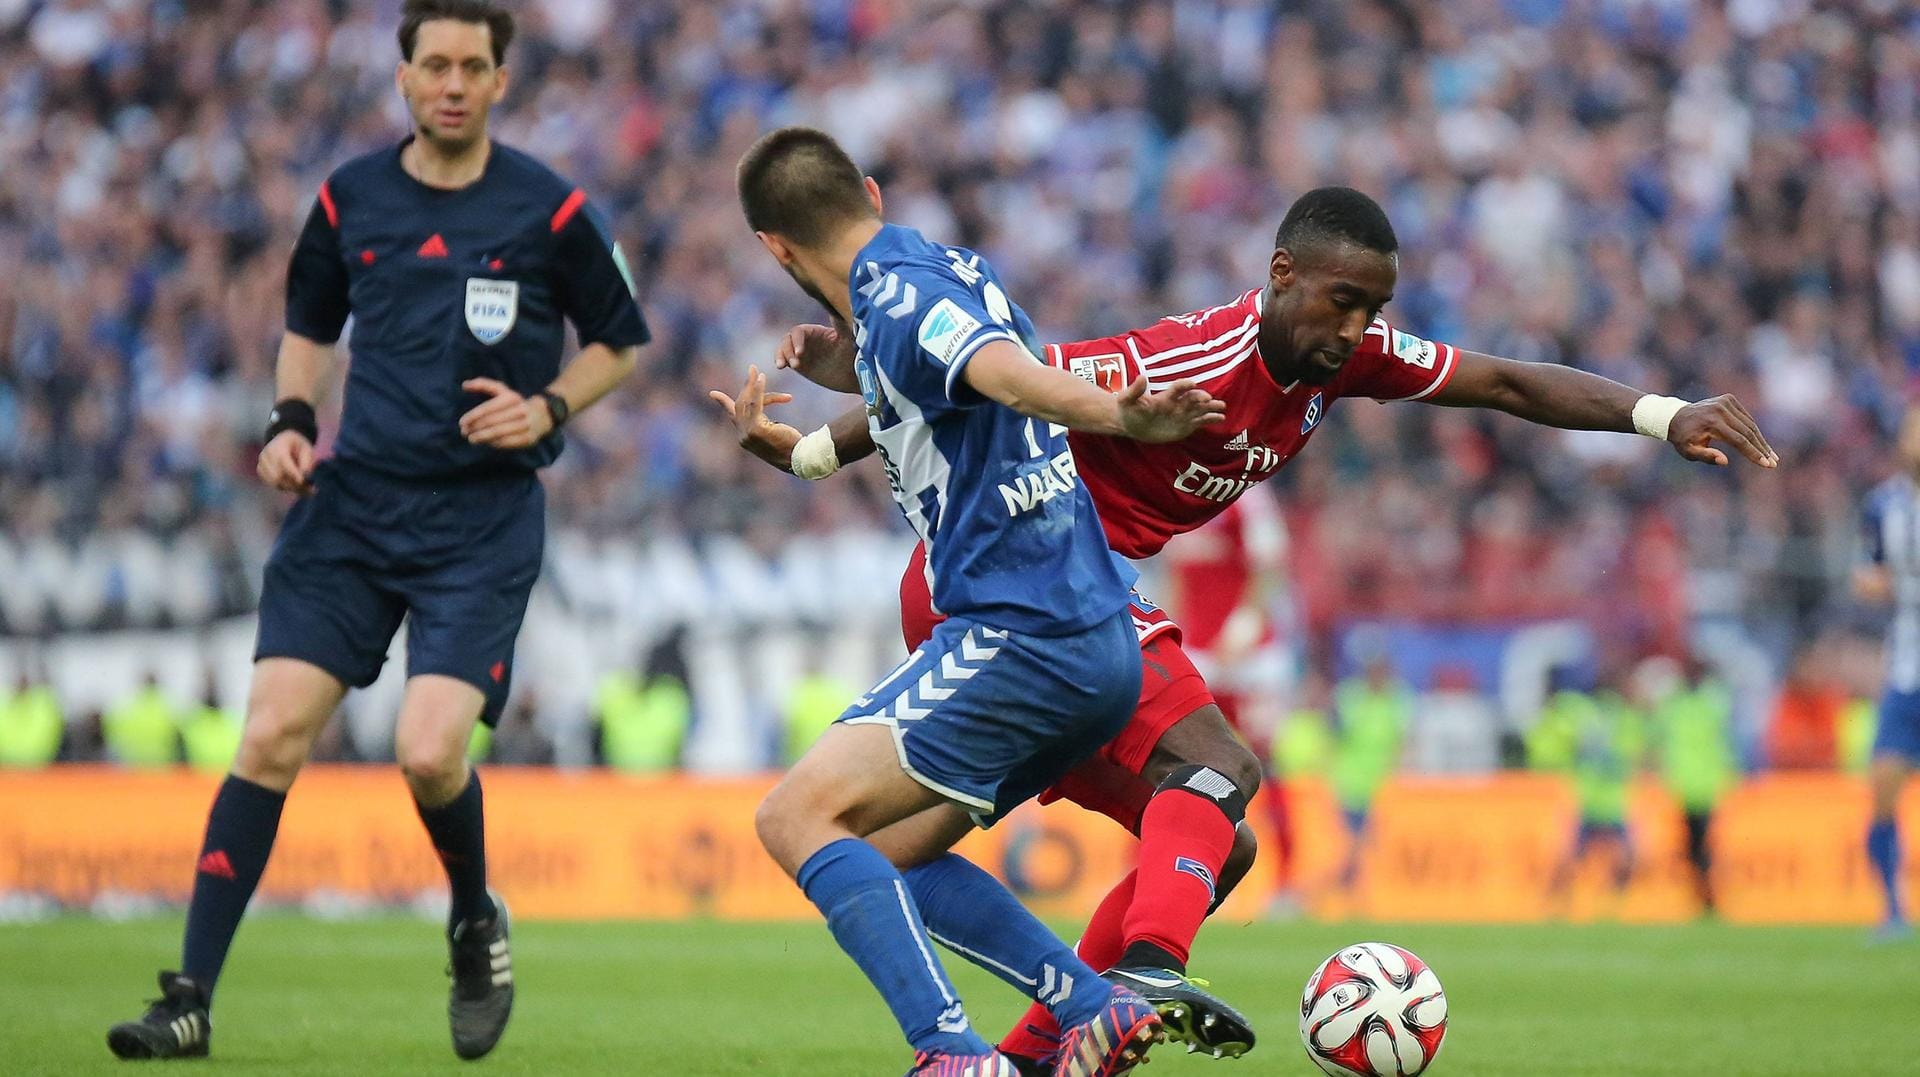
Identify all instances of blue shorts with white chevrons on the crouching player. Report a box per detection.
[839,607,1140,827]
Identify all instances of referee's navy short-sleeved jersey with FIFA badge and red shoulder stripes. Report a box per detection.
[286,142,647,478]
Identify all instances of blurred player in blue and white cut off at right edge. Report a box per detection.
[1855,407,1920,939]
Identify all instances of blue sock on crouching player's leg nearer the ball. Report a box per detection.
[906,852,1112,1029]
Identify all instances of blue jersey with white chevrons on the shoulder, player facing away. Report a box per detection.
[849,225,1135,635]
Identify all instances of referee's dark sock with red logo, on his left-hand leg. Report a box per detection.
[180,774,286,1000]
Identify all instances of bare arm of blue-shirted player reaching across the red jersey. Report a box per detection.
[960,340,1227,442]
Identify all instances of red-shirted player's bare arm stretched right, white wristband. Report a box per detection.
[1428,351,1780,468]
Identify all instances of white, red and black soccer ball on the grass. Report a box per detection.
[1300,943,1446,1077]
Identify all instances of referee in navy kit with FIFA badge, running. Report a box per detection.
[108,0,647,1058]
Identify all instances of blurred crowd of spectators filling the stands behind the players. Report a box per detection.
[0,0,1920,771]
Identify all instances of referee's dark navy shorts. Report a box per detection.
[253,461,547,726]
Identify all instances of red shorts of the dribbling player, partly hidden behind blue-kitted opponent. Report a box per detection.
[900,545,1213,831]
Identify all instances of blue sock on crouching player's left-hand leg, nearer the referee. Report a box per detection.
[795,837,993,1054]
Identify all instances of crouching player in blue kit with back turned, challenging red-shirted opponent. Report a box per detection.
[737,127,1221,1077]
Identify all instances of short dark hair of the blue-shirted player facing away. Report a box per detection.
[735,127,876,248]
